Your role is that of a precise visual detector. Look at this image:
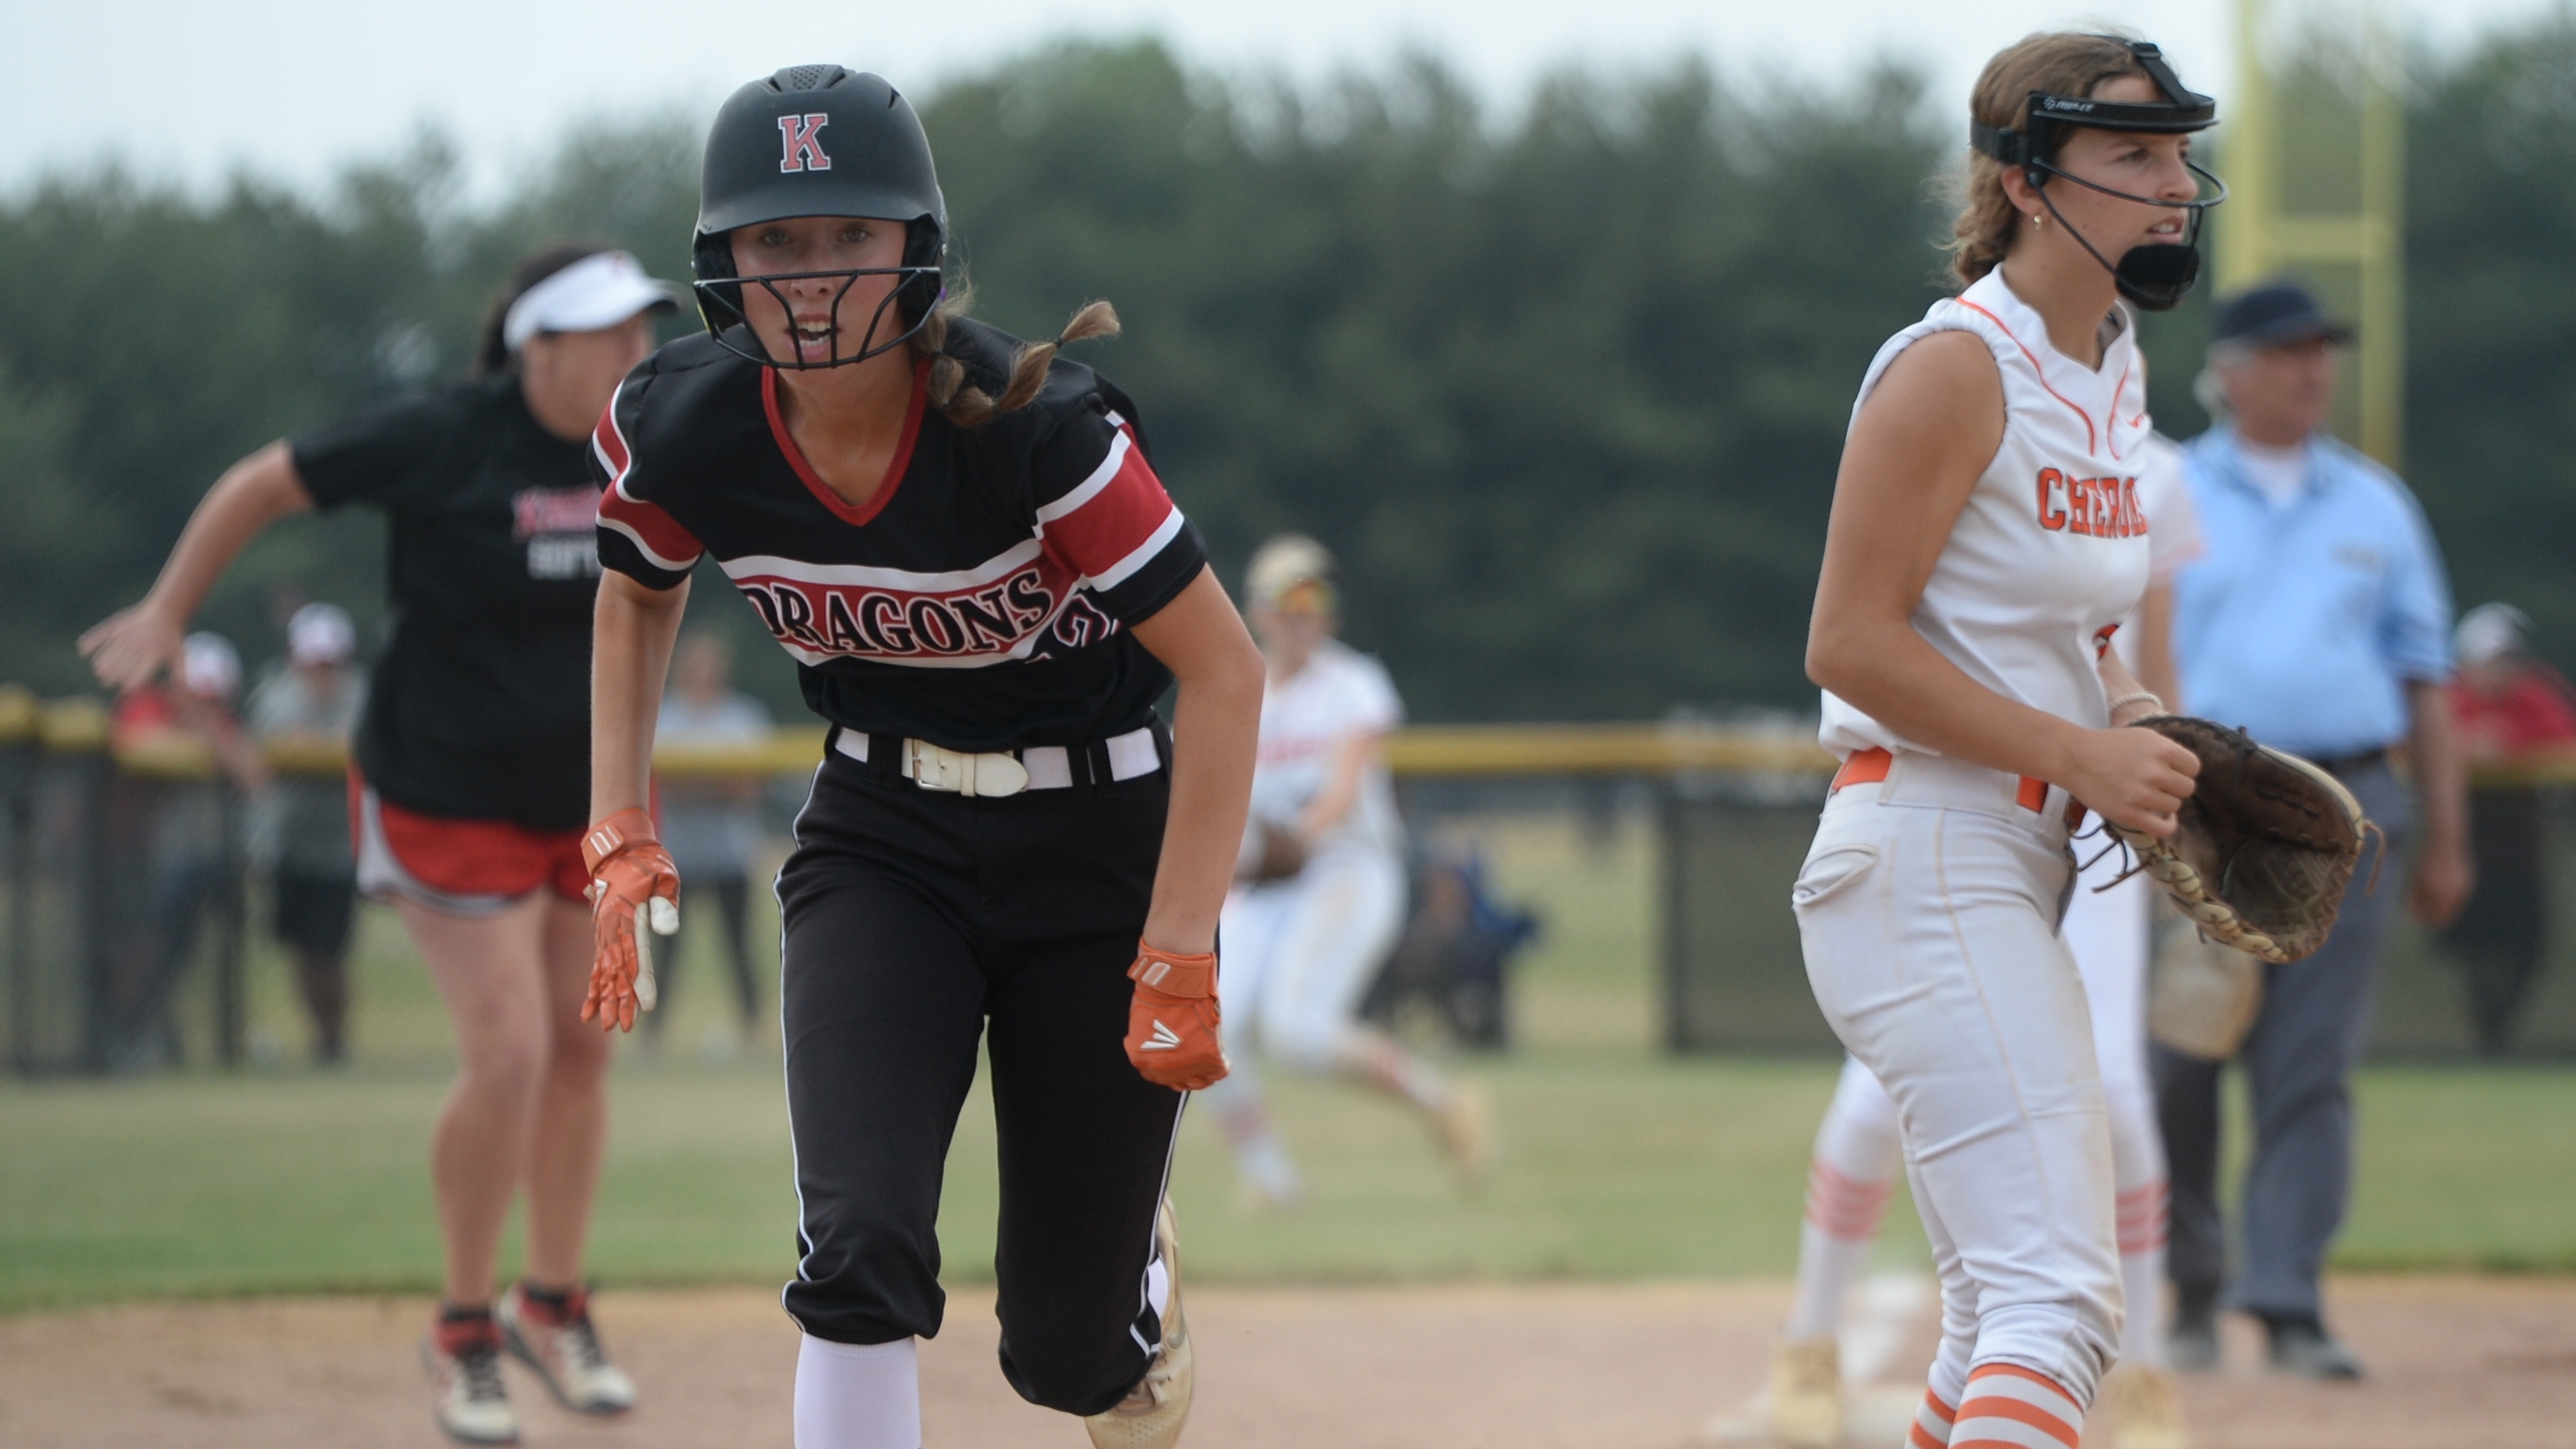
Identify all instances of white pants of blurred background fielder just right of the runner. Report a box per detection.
[1216,848,1404,1073]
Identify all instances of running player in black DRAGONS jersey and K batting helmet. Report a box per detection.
[585,64,1262,1449]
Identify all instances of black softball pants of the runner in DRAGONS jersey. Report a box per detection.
[778,732,1182,1412]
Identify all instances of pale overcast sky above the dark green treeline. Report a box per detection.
[0,0,2571,190]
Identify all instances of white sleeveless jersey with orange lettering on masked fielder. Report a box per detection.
[1816,270,2154,755]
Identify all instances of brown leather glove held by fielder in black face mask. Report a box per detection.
[2112,715,2378,964]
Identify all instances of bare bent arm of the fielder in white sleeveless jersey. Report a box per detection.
[1806,333,2197,835]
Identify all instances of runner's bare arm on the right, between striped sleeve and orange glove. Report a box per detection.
[1136,570,1262,956]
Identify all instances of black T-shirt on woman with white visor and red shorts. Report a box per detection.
[291,376,601,830]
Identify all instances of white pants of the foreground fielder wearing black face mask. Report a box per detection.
[1790,753,2120,1406]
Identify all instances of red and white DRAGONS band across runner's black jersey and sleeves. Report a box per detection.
[595,394,1182,668]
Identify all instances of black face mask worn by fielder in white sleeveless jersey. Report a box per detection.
[1968,41,2228,312]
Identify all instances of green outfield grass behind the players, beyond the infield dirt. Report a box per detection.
[0,799,2576,1310]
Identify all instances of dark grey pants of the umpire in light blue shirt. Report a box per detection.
[2151,761,2413,1318]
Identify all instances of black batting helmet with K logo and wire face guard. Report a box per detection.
[690,64,948,369]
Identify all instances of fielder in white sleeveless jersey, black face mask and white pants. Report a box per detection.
[1793,34,2215,1449]
